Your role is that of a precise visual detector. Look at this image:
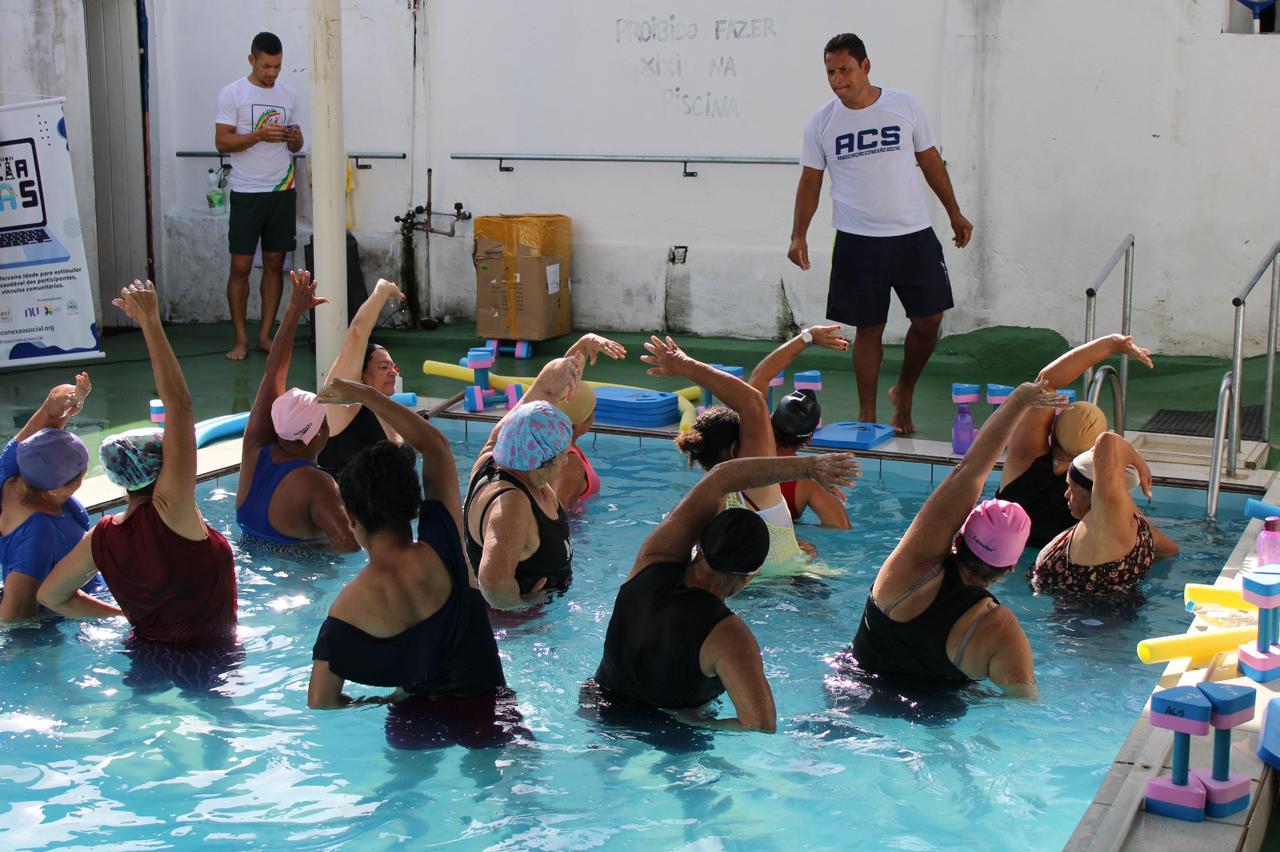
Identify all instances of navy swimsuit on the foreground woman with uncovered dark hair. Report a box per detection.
[311,500,507,698]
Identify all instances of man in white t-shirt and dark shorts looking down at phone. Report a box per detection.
[214,32,302,361]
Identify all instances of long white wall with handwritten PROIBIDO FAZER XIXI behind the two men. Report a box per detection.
[154,0,1280,354]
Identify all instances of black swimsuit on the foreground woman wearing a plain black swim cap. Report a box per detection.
[595,562,732,709]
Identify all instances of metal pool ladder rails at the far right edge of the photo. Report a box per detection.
[1204,241,1280,518]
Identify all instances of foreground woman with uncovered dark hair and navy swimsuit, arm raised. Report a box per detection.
[307,380,506,716]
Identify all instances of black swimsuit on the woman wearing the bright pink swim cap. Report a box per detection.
[854,556,1000,683]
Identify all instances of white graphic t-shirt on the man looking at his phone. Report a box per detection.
[214,77,297,192]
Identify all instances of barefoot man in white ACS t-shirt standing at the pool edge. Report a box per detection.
[787,33,973,435]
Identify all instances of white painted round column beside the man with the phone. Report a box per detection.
[307,0,347,390]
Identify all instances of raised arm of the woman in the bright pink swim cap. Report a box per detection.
[881,383,1066,572]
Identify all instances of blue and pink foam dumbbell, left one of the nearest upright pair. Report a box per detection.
[1147,687,1213,823]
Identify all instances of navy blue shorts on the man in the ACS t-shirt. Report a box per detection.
[827,228,955,326]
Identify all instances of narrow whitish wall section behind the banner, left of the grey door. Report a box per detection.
[0,0,102,327]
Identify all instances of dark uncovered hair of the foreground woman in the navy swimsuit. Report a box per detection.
[338,441,422,536]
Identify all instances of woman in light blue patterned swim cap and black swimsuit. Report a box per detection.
[462,354,582,609]
